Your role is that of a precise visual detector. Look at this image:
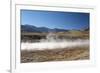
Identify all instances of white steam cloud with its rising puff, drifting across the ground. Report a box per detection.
[21,33,89,50]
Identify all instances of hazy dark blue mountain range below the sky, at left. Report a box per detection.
[21,25,68,32]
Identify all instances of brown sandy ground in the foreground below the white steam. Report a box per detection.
[21,46,89,63]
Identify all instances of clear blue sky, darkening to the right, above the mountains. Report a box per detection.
[21,10,89,30]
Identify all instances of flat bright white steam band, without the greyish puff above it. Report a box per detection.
[21,40,89,50]
